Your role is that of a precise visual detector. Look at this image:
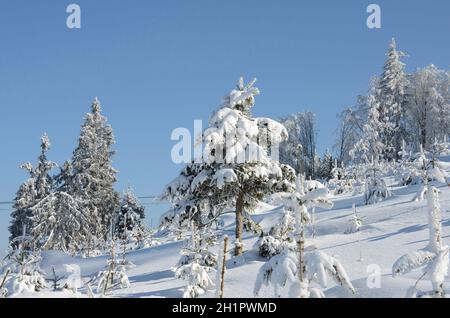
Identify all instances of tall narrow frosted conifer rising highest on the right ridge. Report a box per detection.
[379,38,406,161]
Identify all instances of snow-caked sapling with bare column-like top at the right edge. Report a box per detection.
[392,187,449,297]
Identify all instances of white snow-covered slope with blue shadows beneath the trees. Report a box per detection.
[0,157,450,298]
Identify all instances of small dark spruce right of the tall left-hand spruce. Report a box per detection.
[115,188,145,246]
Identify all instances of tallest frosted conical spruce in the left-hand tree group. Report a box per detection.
[60,98,119,250]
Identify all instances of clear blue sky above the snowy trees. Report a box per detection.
[0,0,450,255]
